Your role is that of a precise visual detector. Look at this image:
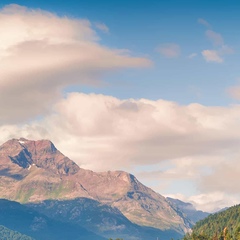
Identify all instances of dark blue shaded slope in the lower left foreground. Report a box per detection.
[0,199,106,240]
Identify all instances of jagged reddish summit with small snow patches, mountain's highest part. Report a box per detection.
[0,138,79,175]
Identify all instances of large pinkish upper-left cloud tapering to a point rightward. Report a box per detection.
[0,5,151,123]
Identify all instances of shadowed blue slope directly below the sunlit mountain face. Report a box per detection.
[26,198,181,240]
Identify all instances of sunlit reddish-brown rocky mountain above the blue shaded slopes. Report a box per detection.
[0,138,191,238]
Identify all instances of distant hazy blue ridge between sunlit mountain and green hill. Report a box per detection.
[167,197,210,226]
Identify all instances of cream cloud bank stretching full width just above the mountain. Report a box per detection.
[0,93,240,209]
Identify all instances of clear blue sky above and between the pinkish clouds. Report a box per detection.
[1,0,240,105]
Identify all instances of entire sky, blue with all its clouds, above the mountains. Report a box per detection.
[0,0,240,211]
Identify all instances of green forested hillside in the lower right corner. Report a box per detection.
[184,205,240,240]
